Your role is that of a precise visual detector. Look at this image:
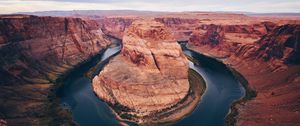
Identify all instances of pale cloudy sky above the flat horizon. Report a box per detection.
[0,0,300,14]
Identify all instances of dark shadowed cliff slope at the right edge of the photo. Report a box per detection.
[240,24,300,64]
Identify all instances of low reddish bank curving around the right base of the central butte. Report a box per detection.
[107,68,207,125]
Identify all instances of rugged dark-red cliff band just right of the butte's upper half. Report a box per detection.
[190,22,275,46]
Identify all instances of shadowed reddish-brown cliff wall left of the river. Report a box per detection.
[0,16,109,84]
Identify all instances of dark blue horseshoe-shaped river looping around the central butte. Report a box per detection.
[58,39,245,126]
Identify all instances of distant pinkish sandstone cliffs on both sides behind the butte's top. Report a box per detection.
[98,13,284,40]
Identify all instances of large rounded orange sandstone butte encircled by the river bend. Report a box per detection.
[93,20,189,123]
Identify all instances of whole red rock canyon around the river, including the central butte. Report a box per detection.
[0,12,300,126]
